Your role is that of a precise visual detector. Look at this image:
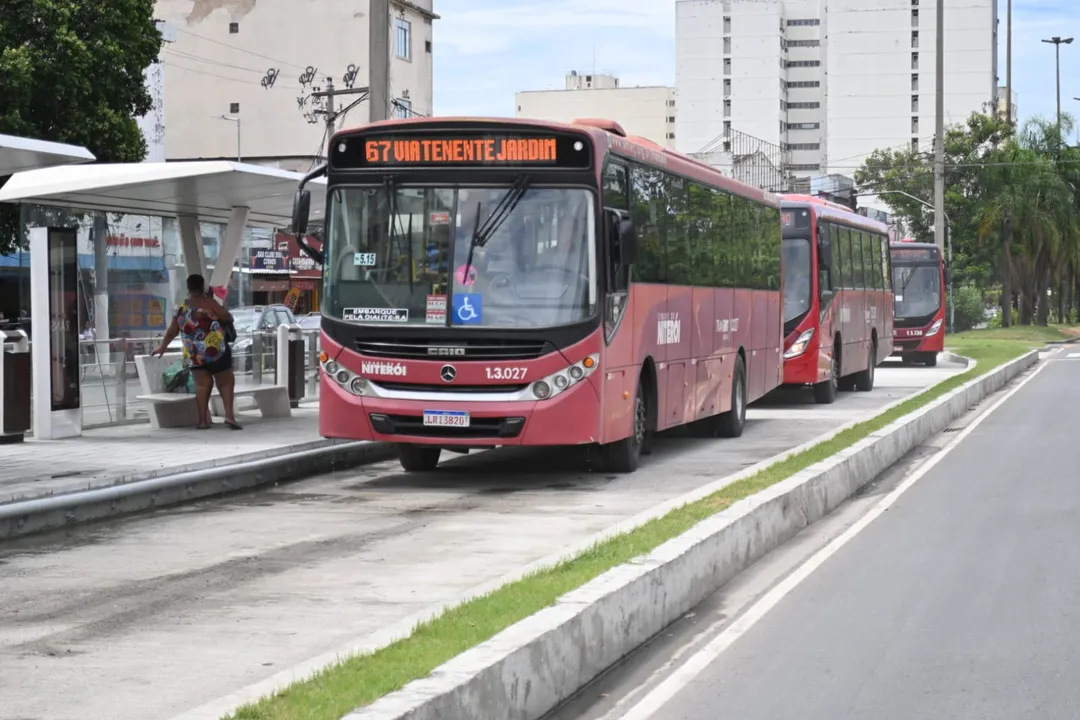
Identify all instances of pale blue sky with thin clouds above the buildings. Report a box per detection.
[434,0,1080,142]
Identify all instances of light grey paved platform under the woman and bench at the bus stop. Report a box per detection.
[0,406,393,518]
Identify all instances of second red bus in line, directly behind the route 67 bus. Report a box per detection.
[781,195,893,403]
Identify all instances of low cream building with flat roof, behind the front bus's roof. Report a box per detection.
[514,70,677,148]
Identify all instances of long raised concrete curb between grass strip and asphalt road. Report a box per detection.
[343,351,1039,720]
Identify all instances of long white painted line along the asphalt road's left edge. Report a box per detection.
[605,363,1049,720]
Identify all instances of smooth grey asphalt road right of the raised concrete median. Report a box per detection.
[574,350,1080,720]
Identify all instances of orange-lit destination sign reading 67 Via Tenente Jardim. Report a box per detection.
[333,130,592,169]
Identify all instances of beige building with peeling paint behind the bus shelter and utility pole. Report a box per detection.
[156,0,437,171]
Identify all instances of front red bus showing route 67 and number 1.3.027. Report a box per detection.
[294,118,783,472]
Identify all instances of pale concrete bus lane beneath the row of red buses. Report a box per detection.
[0,363,960,720]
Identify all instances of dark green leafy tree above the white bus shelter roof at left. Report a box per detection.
[0,0,161,253]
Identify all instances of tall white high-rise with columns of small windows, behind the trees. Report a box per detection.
[675,0,998,184]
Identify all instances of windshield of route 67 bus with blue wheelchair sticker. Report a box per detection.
[323,186,597,328]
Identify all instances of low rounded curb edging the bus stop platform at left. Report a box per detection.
[0,443,397,541]
